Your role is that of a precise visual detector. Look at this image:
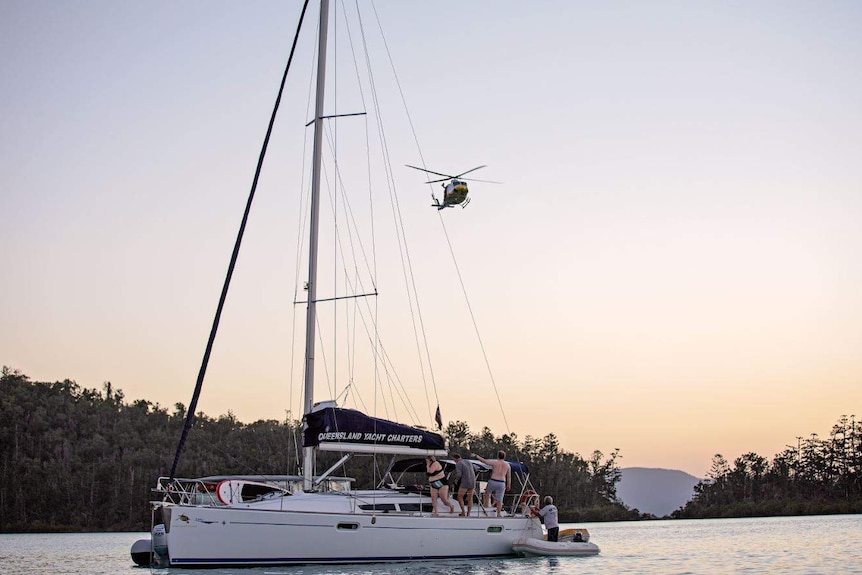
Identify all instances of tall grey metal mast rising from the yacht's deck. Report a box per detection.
[302,0,329,491]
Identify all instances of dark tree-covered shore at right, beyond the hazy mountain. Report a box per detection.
[672,415,862,518]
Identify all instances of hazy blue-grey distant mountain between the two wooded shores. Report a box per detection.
[617,467,700,517]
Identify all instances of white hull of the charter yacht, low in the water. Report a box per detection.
[162,494,542,567]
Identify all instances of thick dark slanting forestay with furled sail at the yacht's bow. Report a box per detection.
[170,0,308,479]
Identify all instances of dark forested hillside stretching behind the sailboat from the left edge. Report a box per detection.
[0,367,637,532]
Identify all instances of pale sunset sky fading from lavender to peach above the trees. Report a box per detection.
[0,0,862,476]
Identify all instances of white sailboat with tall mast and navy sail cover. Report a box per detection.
[132,0,543,568]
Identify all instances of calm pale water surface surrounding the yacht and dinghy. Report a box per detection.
[0,515,862,575]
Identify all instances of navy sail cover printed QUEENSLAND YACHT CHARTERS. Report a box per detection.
[302,407,446,455]
